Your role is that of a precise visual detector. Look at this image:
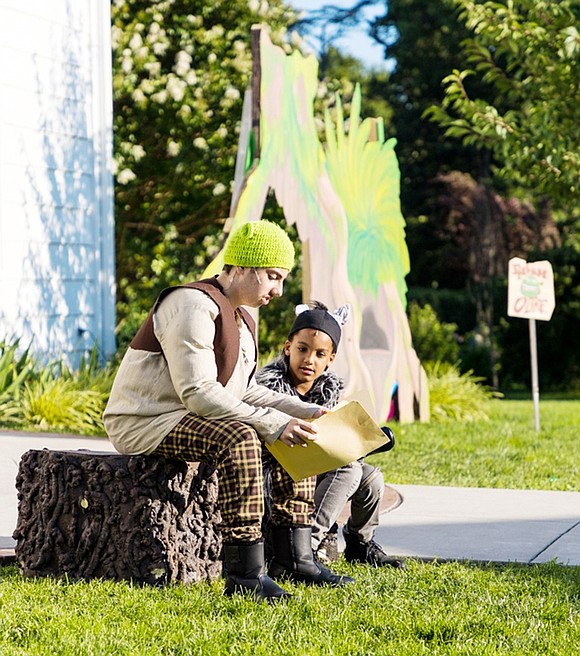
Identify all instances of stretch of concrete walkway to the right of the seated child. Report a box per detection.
[376,485,580,565]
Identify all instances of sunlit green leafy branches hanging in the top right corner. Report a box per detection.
[426,0,580,209]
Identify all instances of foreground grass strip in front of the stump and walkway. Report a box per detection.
[0,561,580,656]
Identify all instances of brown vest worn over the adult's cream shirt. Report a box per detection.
[129,278,258,386]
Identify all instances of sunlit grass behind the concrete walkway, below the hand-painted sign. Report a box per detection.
[370,400,580,492]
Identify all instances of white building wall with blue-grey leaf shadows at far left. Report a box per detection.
[0,0,115,366]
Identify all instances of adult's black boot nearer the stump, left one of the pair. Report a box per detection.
[223,542,292,602]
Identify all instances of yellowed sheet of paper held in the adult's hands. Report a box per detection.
[267,401,389,481]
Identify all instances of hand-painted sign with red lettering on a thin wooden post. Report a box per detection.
[508,257,556,432]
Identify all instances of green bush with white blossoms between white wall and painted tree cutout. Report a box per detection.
[112,0,294,341]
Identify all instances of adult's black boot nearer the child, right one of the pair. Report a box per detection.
[268,526,354,586]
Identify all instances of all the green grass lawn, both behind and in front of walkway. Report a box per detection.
[0,401,580,656]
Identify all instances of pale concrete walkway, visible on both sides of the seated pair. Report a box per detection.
[0,432,580,566]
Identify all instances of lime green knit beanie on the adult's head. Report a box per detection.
[224,220,294,271]
